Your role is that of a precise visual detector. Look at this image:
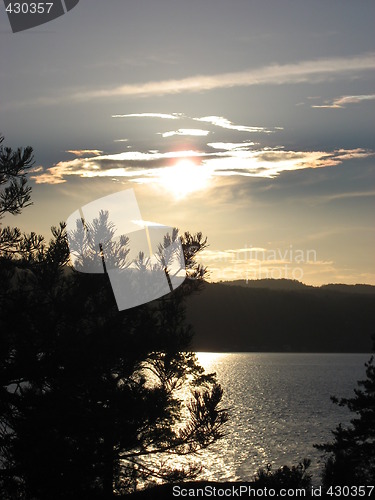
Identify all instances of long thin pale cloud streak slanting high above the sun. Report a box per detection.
[70,53,374,100]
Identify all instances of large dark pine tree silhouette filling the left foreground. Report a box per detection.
[0,140,227,500]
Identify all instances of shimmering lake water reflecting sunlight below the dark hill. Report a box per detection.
[198,353,370,484]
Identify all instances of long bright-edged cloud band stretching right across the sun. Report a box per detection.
[32,143,374,184]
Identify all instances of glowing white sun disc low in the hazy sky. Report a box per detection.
[158,159,211,199]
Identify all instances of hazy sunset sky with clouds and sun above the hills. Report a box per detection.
[0,0,375,286]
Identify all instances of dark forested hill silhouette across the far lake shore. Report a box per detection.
[187,280,375,352]
